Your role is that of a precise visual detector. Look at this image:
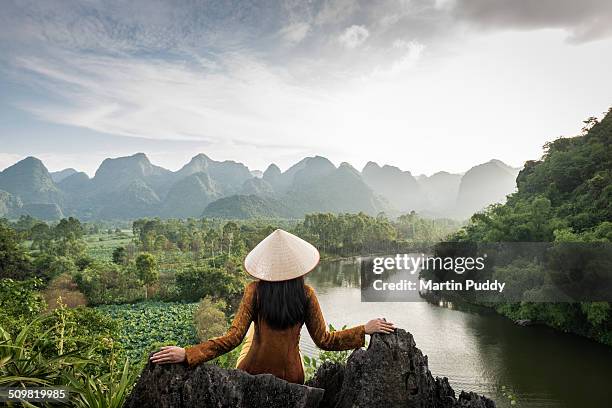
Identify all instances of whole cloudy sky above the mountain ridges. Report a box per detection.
[0,0,612,176]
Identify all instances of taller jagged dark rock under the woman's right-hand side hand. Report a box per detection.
[308,329,495,408]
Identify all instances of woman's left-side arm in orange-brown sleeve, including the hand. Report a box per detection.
[151,282,256,366]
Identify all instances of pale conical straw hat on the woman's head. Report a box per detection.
[244,229,319,282]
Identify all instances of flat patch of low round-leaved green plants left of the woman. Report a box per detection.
[96,302,198,361]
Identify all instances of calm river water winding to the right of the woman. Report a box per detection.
[301,259,612,408]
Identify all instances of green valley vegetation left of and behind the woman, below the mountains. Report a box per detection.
[0,207,458,407]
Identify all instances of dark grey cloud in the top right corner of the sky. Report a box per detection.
[452,0,612,42]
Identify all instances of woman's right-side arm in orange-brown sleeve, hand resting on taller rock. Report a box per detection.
[306,286,394,351]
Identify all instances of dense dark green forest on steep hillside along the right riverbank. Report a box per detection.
[440,109,612,345]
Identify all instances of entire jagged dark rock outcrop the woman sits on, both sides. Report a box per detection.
[125,329,495,408]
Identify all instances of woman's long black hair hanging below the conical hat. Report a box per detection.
[256,277,308,330]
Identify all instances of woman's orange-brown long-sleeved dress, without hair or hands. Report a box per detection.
[185,282,365,384]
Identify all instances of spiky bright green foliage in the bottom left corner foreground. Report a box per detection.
[0,309,138,408]
